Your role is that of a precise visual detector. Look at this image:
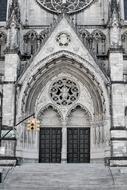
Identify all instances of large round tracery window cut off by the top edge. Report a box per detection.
[36,0,94,13]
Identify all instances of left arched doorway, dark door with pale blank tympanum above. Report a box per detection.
[38,105,62,163]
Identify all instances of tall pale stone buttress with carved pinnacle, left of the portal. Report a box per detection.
[3,1,20,126]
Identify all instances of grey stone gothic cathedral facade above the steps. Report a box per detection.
[0,0,127,165]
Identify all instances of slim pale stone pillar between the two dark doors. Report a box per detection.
[61,122,67,163]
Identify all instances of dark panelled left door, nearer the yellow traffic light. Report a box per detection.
[39,128,62,163]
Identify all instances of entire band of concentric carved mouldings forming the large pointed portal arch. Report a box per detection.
[19,51,108,121]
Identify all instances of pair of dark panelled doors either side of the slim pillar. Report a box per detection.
[39,127,90,163]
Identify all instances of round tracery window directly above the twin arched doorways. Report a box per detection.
[50,78,79,106]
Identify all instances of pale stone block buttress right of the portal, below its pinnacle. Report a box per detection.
[109,49,127,165]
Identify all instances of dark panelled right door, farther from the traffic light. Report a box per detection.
[67,128,90,163]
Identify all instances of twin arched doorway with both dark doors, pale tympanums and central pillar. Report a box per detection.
[38,105,91,163]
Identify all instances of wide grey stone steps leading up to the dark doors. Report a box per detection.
[0,163,127,190]
